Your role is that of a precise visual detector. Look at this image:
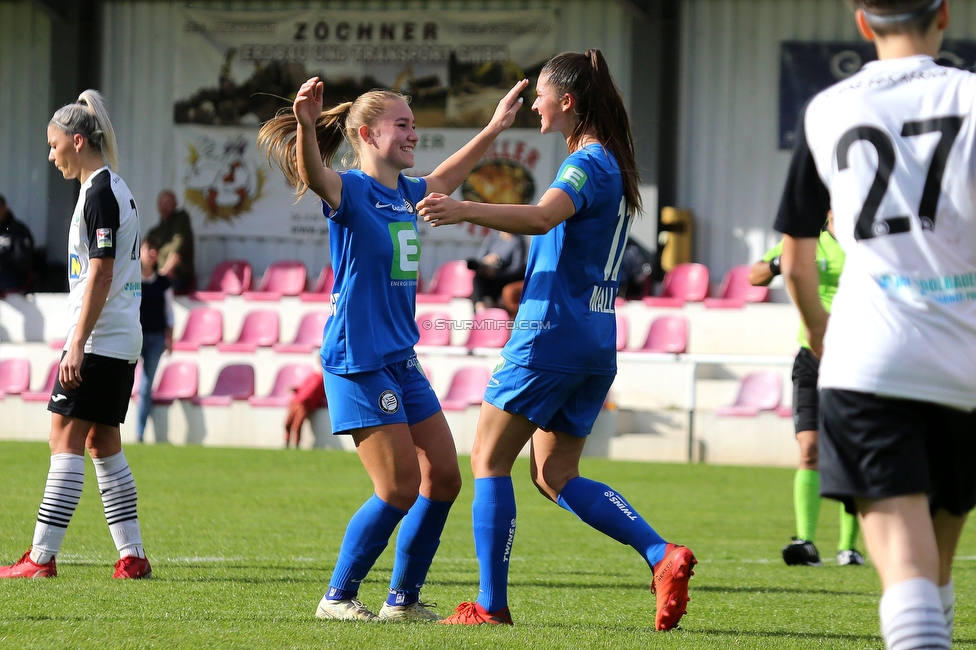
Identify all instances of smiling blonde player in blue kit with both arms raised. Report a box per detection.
[258,77,528,620]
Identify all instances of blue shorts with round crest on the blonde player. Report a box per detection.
[322,356,441,435]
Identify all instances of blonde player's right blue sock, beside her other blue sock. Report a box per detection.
[386,495,454,605]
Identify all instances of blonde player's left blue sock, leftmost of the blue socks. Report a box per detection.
[328,494,407,600]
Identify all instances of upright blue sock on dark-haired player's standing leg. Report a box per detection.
[471,476,515,612]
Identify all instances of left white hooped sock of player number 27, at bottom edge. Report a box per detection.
[878,578,949,650]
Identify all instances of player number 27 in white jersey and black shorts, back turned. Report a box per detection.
[776,0,976,650]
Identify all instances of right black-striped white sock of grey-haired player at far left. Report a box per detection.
[92,451,146,557]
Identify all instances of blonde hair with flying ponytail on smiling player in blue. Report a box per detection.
[258,90,410,197]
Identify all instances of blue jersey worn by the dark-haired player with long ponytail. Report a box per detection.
[502,144,630,375]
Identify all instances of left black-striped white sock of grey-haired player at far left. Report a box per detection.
[31,454,85,564]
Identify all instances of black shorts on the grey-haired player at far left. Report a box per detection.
[47,353,136,427]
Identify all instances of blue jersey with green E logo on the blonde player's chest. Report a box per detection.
[322,169,427,375]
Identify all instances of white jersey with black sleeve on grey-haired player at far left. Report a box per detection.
[65,167,142,362]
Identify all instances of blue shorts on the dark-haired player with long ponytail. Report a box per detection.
[485,359,613,438]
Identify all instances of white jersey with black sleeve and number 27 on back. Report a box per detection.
[776,56,976,409]
